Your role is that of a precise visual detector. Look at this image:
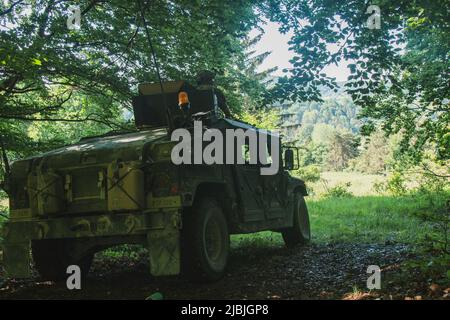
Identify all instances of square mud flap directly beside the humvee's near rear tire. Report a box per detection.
[147,228,180,276]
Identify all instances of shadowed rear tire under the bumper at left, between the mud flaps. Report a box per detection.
[31,240,94,281]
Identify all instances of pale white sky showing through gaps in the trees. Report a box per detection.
[250,22,350,81]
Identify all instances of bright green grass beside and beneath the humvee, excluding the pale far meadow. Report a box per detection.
[233,196,431,246]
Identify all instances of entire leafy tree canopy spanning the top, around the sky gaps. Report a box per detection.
[0,0,450,175]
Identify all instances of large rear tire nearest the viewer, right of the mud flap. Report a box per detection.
[181,198,230,282]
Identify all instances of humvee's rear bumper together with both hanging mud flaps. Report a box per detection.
[1,209,181,278]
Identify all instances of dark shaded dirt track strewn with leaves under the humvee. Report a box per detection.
[0,244,436,300]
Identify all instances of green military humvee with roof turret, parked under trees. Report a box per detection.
[2,81,310,281]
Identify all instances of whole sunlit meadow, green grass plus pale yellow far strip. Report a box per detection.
[232,172,444,247]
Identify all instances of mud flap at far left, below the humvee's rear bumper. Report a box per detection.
[2,242,31,278]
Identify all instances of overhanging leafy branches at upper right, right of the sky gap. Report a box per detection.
[264,0,450,159]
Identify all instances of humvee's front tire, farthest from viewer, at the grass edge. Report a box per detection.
[281,192,311,248]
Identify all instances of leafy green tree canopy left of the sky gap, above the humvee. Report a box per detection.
[0,0,266,160]
